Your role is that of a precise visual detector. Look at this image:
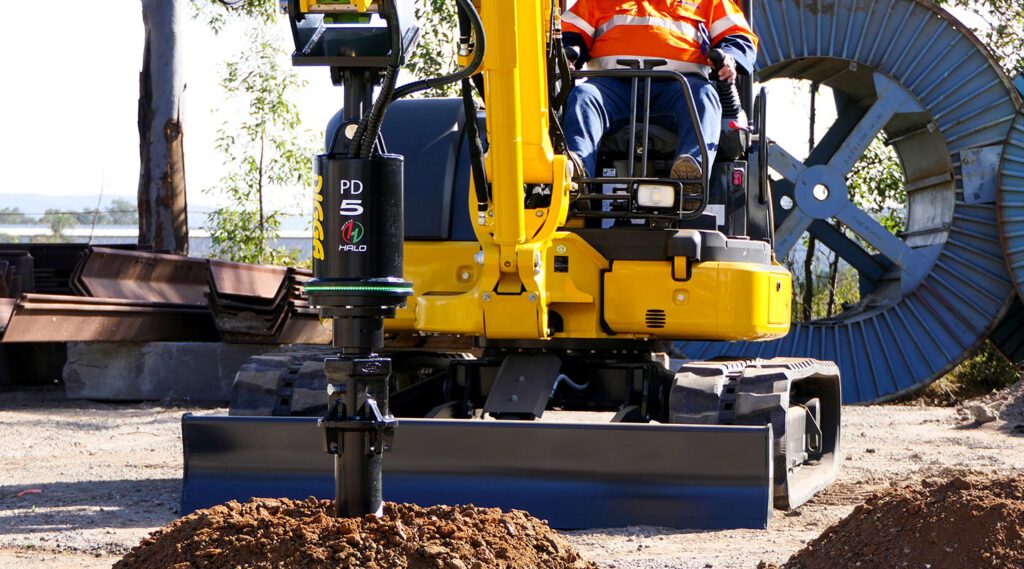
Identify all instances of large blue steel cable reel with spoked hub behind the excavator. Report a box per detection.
[679,0,1024,403]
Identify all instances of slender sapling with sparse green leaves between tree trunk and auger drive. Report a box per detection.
[195,1,314,264]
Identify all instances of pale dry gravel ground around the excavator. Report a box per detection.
[0,389,1024,569]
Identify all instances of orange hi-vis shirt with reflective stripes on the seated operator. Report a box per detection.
[562,0,758,76]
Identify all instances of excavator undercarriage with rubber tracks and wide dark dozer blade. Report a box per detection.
[182,346,841,528]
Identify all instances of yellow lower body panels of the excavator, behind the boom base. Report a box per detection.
[387,231,793,341]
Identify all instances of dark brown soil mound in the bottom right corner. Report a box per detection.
[762,477,1024,569]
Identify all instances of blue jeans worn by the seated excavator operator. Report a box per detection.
[562,75,722,177]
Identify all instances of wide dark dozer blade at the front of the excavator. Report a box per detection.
[181,414,772,529]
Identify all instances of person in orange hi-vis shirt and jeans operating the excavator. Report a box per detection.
[562,0,758,180]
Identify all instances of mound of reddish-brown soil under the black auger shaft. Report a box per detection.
[114,498,596,569]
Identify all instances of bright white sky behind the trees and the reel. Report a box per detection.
[0,0,991,217]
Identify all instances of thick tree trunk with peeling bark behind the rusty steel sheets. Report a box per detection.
[138,0,188,254]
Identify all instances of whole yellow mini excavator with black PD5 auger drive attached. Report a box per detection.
[182,0,841,528]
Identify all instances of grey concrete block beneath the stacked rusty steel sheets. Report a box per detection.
[63,342,278,404]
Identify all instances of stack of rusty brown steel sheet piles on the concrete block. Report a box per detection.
[0,244,330,344]
